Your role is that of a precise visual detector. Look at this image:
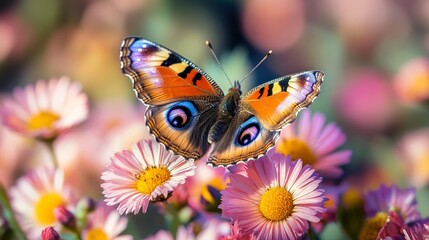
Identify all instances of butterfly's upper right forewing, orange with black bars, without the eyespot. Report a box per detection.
[242,71,324,130]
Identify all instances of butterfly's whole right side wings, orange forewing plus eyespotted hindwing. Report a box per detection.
[208,71,324,166]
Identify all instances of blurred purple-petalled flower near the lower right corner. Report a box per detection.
[365,185,420,223]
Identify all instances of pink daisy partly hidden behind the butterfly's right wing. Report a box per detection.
[276,110,351,178]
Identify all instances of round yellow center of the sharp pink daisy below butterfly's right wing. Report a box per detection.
[259,187,294,221]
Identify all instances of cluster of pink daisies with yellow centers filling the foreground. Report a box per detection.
[1,78,429,239]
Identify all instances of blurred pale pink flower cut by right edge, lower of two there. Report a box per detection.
[397,128,429,187]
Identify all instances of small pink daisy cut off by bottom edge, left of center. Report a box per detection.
[82,202,133,240]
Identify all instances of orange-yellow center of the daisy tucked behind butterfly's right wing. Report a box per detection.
[277,138,317,165]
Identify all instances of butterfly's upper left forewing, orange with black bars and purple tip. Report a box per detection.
[121,37,223,105]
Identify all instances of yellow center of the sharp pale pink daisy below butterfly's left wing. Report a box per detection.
[136,167,171,195]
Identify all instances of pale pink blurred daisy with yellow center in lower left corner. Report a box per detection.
[10,167,75,239]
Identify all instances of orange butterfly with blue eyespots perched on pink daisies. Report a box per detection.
[120,37,324,166]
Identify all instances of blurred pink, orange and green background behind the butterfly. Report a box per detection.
[0,0,429,239]
